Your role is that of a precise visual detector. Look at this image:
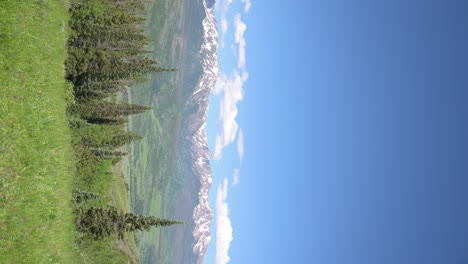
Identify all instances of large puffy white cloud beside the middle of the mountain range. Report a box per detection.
[213,70,248,160]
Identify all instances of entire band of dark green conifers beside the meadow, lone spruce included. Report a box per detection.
[65,0,181,239]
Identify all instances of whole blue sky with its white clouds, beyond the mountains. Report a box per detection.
[205,0,468,264]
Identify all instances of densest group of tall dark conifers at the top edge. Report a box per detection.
[65,0,174,91]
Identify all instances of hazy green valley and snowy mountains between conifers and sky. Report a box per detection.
[125,0,218,264]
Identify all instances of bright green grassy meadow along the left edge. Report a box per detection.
[0,0,79,263]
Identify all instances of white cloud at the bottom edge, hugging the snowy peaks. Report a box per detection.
[215,178,233,264]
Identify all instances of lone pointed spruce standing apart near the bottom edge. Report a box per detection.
[77,206,183,239]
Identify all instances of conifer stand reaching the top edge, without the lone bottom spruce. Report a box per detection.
[65,0,161,168]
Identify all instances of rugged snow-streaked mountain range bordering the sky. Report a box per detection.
[181,2,218,264]
